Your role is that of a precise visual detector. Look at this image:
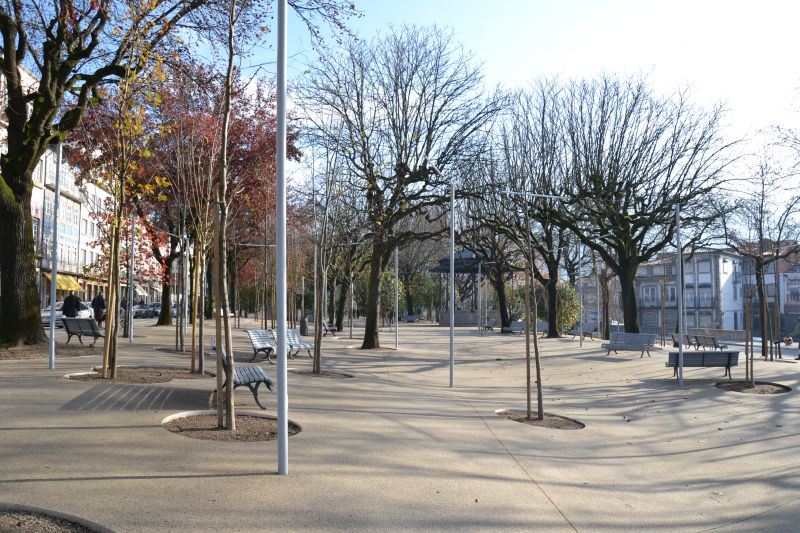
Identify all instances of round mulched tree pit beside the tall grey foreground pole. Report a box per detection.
[162,414,302,442]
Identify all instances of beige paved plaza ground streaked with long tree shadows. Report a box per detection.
[0,321,800,532]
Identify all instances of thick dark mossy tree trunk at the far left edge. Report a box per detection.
[0,183,47,346]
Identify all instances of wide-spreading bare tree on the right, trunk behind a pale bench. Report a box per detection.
[558,76,733,332]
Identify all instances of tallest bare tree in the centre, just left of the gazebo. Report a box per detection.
[301,26,499,349]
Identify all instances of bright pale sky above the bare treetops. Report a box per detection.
[253,0,800,175]
